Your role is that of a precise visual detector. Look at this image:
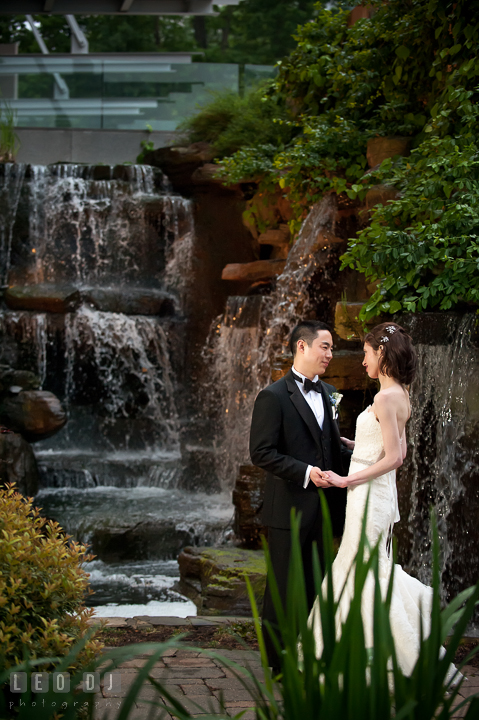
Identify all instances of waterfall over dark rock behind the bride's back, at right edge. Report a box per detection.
[398,314,479,612]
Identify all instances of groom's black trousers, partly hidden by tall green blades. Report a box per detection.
[262,513,324,668]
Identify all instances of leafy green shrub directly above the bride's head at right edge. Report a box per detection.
[343,137,479,320]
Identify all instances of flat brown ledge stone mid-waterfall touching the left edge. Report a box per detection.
[4,285,81,313]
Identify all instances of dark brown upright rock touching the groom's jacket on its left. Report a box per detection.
[233,465,266,550]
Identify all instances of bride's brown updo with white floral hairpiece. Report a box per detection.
[364,322,417,385]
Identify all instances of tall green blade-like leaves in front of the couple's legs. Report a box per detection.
[246,494,479,720]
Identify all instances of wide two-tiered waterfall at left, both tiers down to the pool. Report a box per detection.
[0,164,194,488]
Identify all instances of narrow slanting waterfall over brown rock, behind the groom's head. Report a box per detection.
[203,195,337,487]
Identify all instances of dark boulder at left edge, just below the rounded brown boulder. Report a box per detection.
[0,432,38,497]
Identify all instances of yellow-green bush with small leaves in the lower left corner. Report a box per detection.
[0,485,101,668]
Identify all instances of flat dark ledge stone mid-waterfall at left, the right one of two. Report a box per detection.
[82,287,175,317]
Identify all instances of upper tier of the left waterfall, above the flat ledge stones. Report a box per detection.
[19,165,191,285]
